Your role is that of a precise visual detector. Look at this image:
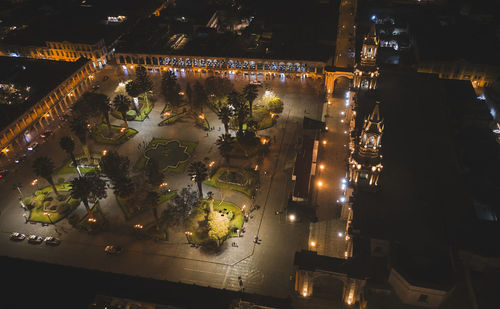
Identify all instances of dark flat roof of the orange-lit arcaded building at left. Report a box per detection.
[0,56,88,129]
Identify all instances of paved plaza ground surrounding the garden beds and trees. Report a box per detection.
[0,66,324,298]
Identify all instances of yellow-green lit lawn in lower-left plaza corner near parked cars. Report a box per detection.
[24,184,80,223]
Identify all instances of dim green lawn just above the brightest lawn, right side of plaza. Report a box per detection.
[204,167,258,197]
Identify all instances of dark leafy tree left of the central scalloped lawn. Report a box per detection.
[100,151,134,197]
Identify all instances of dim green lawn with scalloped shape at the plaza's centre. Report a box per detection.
[135,138,198,173]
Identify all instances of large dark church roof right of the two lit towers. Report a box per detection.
[352,68,464,286]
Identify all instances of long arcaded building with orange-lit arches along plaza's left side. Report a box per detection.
[0,57,96,159]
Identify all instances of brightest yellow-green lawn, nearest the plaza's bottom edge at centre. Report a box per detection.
[186,200,245,245]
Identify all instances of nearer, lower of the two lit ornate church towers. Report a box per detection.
[349,101,384,186]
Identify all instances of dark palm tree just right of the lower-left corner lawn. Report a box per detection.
[69,172,107,219]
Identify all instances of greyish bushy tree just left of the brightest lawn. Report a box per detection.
[165,186,200,225]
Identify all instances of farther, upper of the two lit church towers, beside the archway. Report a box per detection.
[354,23,379,89]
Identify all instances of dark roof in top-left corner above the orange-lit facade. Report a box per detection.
[2,0,161,46]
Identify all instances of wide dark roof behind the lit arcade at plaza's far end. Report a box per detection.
[117,0,338,61]
